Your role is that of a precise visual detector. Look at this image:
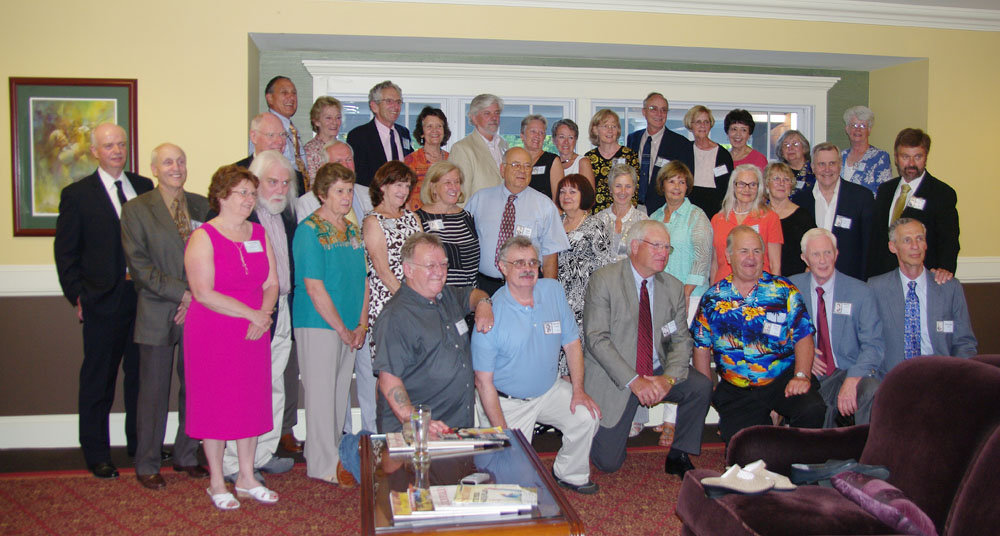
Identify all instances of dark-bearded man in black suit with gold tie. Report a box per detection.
[868,128,960,276]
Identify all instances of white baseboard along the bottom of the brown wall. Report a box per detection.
[0,404,719,450]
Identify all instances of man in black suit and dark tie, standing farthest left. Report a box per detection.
[53,123,153,478]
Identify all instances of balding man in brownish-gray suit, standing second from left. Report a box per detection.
[122,143,208,489]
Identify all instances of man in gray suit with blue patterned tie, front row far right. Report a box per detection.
[868,218,976,372]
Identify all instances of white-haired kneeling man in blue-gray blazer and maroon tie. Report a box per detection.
[789,228,885,428]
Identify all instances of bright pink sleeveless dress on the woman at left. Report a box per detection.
[184,223,273,440]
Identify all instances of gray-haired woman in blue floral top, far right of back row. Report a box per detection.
[840,106,892,195]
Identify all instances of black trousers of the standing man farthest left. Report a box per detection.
[78,281,139,467]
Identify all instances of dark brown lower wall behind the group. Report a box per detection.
[0,283,1000,416]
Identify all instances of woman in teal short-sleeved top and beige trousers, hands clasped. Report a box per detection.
[292,164,370,484]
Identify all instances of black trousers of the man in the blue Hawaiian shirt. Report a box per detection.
[712,367,826,444]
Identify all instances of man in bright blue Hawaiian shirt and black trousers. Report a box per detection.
[691,225,824,444]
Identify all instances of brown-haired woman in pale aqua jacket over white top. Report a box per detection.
[649,160,712,306]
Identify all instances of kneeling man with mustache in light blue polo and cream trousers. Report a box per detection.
[470,237,601,494]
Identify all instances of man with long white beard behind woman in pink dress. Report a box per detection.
[222,147,297,483]
